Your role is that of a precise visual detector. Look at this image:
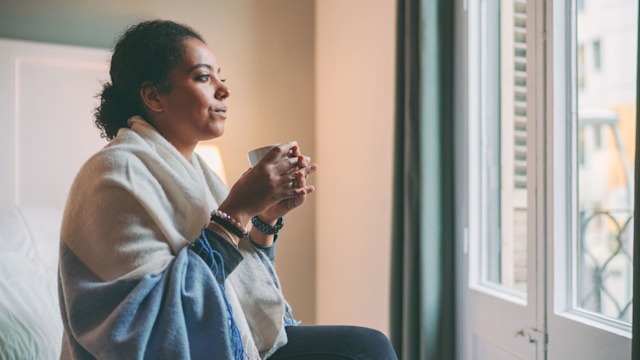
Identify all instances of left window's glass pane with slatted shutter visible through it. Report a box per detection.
[481,0,528,297]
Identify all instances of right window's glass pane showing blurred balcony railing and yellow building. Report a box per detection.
[574,0,638,323]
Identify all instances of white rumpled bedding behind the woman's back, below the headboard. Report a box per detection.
[0,207,62,360]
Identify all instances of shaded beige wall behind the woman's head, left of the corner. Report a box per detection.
[0,0,316,323]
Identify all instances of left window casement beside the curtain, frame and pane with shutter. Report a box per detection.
[458,0,542,359]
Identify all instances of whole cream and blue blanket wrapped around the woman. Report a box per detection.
[59,117,288,359]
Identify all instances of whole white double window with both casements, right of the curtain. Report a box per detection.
[459,0,638,360]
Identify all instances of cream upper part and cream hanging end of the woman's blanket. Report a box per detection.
[61,117,287,358]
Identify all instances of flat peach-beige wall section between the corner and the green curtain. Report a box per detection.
[316,0,396,333]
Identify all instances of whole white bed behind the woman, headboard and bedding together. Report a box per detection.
[0,39,109,360]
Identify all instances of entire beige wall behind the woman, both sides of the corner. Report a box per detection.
[0,0,396,332]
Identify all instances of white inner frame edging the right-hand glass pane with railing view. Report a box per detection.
[546,0,631,339]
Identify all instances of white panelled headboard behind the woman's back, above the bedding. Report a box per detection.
[0,39,109,209]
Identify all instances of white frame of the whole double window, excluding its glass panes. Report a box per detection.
[457,0,631,360]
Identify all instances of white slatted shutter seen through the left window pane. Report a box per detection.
[500,0,527,291]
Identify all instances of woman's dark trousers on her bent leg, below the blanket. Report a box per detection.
[269,326,397,360]
